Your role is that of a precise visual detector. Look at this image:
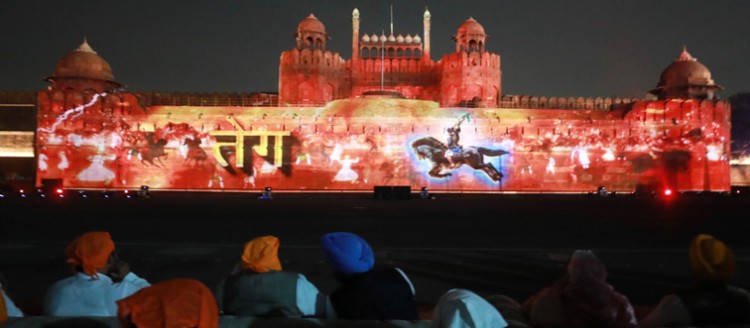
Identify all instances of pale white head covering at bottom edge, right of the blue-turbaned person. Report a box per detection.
[432,289,508,328]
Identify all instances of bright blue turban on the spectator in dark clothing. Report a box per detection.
[320,232,375,273]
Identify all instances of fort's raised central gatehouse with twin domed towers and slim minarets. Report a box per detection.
[279,9,501,107]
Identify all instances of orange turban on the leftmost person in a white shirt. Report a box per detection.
[65,231,115,276]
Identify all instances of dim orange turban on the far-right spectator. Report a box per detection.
[688,234,736,282]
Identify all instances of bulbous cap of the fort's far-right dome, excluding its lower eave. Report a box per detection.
[657,49,714,88]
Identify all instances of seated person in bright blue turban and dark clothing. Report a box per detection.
[321,232,418,321]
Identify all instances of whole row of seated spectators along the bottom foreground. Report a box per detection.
[0,232,750,328]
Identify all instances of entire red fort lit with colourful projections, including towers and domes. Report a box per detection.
[26,9,730,192]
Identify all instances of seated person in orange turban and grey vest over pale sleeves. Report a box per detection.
[217,236,326,317]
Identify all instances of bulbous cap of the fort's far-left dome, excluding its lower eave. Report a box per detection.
[50,39,115,82]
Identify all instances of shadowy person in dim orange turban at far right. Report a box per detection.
[640,234,750,327]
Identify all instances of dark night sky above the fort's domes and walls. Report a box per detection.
[0,0,750,98]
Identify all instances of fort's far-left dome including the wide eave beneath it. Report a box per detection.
[47,38,120,92]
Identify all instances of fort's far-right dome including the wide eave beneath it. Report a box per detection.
[650,47,722,99]
